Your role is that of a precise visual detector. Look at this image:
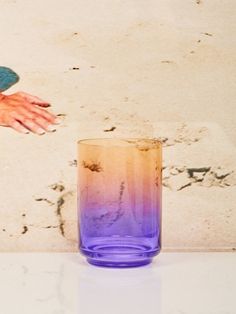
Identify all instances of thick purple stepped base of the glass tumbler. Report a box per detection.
[80,238,160,268]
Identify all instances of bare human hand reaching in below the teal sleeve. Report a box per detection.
[0,92,59,135]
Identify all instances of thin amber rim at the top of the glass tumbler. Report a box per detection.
[77,137,162,146]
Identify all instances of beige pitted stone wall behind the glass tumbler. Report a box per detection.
[0,0,236,251]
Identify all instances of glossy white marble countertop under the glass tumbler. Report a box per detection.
[0,253,236,314]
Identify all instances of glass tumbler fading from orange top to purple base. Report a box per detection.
[78,138,162,267]
